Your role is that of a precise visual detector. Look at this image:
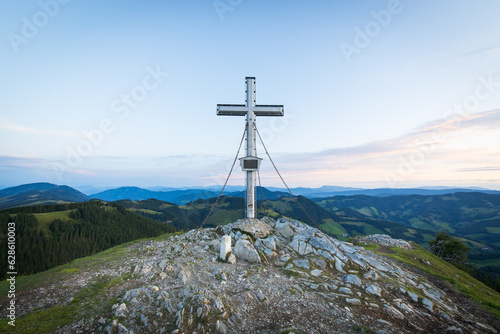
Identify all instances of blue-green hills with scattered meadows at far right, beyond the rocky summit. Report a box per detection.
[315,192,500,259]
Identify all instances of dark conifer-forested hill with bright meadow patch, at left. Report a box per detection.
[0,201,175,280]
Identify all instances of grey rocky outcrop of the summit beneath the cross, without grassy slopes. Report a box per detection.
[8,218,500,334]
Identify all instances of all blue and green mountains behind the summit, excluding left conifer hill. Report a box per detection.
[0,183,500,265]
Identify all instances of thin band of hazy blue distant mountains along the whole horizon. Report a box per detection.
[0,183,500,209]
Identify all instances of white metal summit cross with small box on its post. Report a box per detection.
[217,77,285,218]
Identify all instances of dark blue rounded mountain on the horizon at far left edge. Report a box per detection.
[0,183,91,209]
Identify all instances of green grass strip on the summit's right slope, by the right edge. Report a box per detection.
[374,244,500,319]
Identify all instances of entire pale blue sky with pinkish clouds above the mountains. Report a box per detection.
[0,0,500,190]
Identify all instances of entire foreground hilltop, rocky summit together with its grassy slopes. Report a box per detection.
[0,218,500,334]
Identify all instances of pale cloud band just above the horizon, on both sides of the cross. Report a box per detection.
[0,110,500,188]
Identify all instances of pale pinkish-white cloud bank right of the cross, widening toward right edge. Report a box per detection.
[270,110,500,184]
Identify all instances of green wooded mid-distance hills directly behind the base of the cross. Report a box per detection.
[116,196,435,244]
